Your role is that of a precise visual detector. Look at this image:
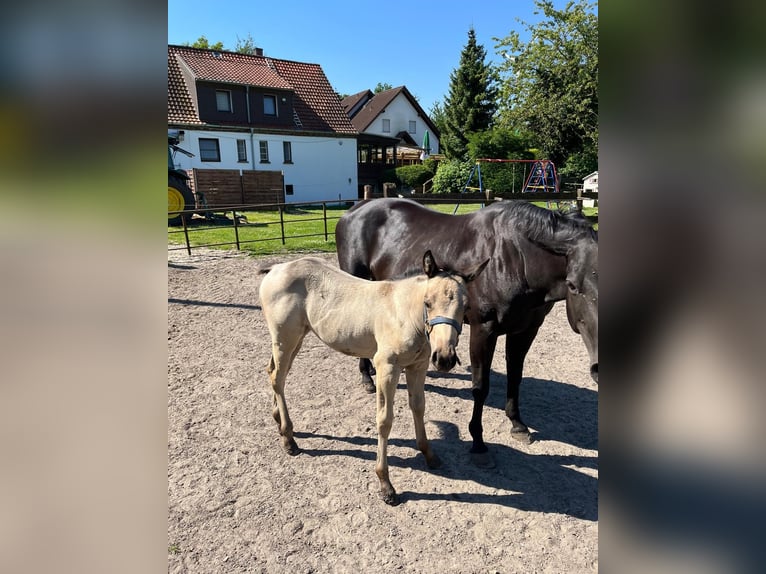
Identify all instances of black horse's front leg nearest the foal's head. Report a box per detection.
[468,325,497,466]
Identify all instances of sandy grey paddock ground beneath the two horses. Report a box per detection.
[168,250,598,574]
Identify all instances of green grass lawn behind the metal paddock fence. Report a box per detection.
[168,201,598,255]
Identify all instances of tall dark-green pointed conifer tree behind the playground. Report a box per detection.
[441,28,497,160]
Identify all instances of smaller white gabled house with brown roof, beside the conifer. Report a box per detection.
[341,86,440,194]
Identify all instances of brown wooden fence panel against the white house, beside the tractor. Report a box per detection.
[190,168,285,209]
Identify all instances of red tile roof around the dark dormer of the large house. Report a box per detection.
[168,45,357,134]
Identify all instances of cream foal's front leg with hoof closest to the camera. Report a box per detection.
[375,357,401,506]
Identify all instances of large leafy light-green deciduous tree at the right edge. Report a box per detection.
[495,0,598,175]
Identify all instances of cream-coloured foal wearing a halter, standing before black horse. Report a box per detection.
[260,251,489,505]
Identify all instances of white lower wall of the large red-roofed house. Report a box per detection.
[174,129,358,203]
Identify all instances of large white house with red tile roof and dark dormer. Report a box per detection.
[168,45,358,203]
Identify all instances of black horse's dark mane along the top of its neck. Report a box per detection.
[503,201,598,248]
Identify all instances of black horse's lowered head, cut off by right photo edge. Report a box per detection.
[566,240,598,383]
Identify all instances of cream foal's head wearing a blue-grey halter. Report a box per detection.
[423,251,489,373]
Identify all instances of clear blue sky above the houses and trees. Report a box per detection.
[168,0,584,112]
